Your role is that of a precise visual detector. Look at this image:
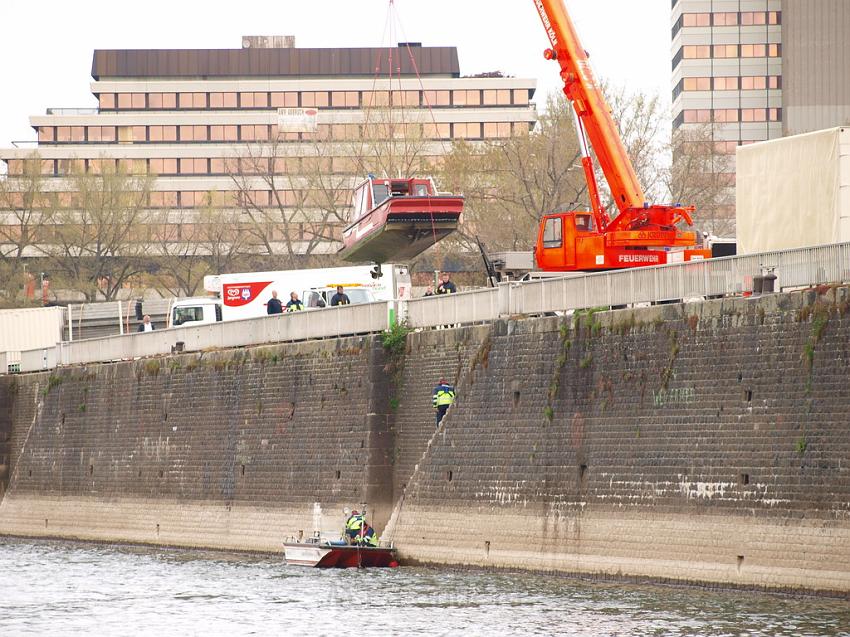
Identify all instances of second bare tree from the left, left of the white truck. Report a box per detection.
[46,161,153,301]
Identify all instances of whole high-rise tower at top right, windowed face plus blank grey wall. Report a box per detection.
[671,0,850,234]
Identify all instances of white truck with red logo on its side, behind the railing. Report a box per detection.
[168,265,410,327]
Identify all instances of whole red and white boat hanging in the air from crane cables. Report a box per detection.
[339,176,464,264]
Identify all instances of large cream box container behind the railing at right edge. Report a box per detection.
[736,128,850,254]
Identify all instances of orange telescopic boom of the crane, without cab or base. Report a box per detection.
[534,0,646,212]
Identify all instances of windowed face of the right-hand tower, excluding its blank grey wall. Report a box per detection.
[671,0,783,234]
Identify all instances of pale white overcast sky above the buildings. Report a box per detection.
[0,0,670,147]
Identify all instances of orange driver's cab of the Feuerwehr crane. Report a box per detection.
[534,212,606,271]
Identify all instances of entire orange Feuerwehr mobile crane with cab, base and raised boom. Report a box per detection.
[534,0,711,272]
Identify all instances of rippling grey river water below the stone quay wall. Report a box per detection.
[0,538,850,637]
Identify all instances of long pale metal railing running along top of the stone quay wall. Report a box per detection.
[0,243,850,373]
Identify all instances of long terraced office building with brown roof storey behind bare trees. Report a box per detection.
[0,37,536,252]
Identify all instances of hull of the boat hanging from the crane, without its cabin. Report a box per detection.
[340,196,463,263]
